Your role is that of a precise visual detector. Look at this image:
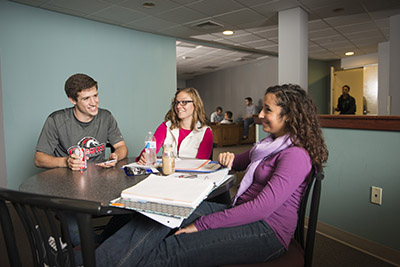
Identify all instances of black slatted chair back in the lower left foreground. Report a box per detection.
[0,188,107,266]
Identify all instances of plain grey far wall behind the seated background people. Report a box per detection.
[186,58,278,121]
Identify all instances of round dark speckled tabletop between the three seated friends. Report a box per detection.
[19,158,236,206]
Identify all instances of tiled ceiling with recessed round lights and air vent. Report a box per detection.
[13,0,400,79]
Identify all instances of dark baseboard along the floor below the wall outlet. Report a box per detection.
[317,222,400,267]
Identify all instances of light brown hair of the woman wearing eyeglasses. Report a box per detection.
[165,87,208,130]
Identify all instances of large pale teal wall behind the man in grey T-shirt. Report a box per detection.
[0,0,176,189]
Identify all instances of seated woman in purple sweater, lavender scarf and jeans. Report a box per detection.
[96,85,328,266]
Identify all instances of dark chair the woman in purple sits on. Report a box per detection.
[225,167,324,267]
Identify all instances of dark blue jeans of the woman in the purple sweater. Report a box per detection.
[96,202,285,267]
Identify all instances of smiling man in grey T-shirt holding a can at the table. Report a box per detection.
[35,74,128,171]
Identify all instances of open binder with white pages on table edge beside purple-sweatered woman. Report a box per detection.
[109,168,231,228]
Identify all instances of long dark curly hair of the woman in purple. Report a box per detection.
[265,84,329,166]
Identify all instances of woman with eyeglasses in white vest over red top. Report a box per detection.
[137,88,213,165]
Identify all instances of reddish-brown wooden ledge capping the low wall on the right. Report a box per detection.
[319,115,400,131]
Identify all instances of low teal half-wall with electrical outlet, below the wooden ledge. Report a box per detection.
[259,126,400,251]
